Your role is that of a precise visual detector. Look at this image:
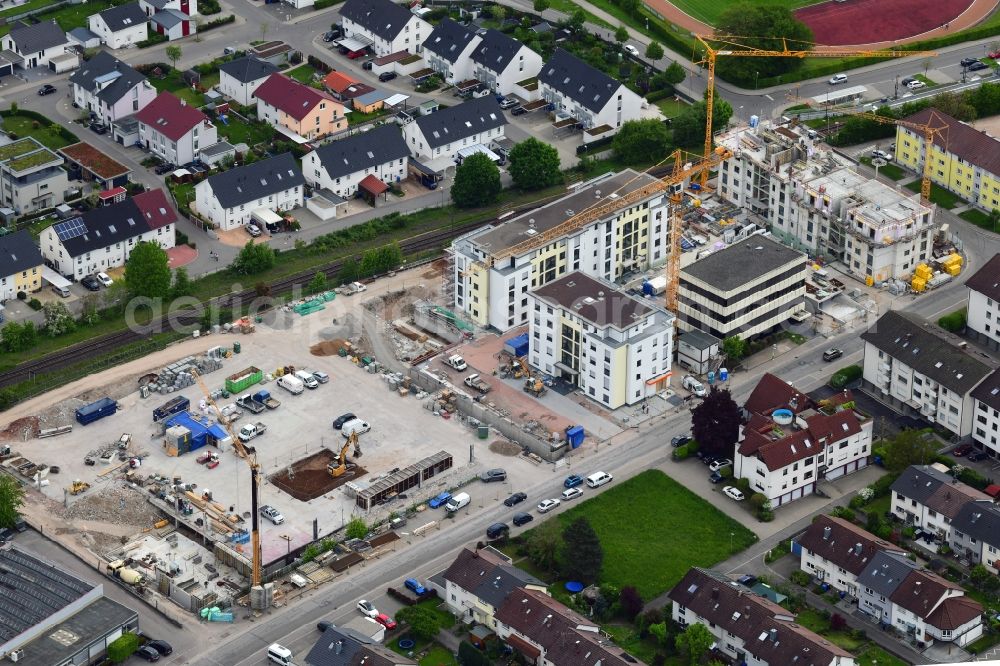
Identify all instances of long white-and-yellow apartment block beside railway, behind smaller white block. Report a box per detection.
[454,169,669,331]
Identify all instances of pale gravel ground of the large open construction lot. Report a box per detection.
[14,264,564,562]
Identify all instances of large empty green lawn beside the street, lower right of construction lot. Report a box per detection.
[536,470,757,599]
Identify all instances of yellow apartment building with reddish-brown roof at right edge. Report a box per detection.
[896,107,1000,210]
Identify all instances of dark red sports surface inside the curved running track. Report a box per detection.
[795,0,974,45]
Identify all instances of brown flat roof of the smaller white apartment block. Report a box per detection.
[532,271,655,329]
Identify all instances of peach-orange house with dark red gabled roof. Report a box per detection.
[254,74,347,143]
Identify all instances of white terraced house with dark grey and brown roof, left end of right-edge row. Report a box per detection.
[889,465,990,543]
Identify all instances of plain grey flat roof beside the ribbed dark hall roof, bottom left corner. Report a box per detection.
[18,597,138,666]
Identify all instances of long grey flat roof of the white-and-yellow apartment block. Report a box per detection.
[469,169,656,254]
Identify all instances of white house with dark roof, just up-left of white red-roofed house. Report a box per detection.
[69,51,157,125]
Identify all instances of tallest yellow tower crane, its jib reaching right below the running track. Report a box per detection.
[694,35,937,187]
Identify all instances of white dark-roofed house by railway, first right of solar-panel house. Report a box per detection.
[194,153,305,231]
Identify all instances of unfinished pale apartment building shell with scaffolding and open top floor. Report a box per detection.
[718,127,936,282]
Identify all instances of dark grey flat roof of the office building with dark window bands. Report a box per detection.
[681,234,806,291]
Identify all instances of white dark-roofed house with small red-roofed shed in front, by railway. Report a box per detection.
[302,123,410,199]
